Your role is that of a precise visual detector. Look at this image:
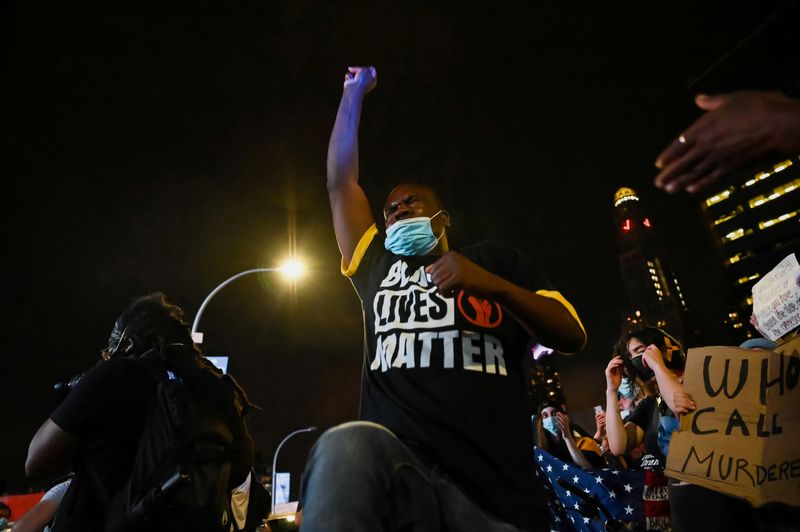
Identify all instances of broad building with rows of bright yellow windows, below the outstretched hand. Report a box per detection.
[701,157,800,338]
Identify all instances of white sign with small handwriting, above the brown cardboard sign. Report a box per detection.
[753,253,800,341]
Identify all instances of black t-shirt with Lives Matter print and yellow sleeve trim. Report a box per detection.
[343,226,580,529]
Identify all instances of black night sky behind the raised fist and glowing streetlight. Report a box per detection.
[0,1,798,489]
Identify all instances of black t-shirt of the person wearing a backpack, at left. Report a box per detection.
[50,358,156,532]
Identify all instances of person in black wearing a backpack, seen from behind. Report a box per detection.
[25,293,260,532]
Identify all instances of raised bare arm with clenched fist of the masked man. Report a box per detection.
[327,67,377,263]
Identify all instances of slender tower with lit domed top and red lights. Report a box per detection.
[614,188,688,338]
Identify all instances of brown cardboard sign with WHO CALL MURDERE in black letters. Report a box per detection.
[665,337,800,506]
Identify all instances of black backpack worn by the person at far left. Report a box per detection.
[92,352,253,532]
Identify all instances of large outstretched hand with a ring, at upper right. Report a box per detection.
[655,91,800,192]
